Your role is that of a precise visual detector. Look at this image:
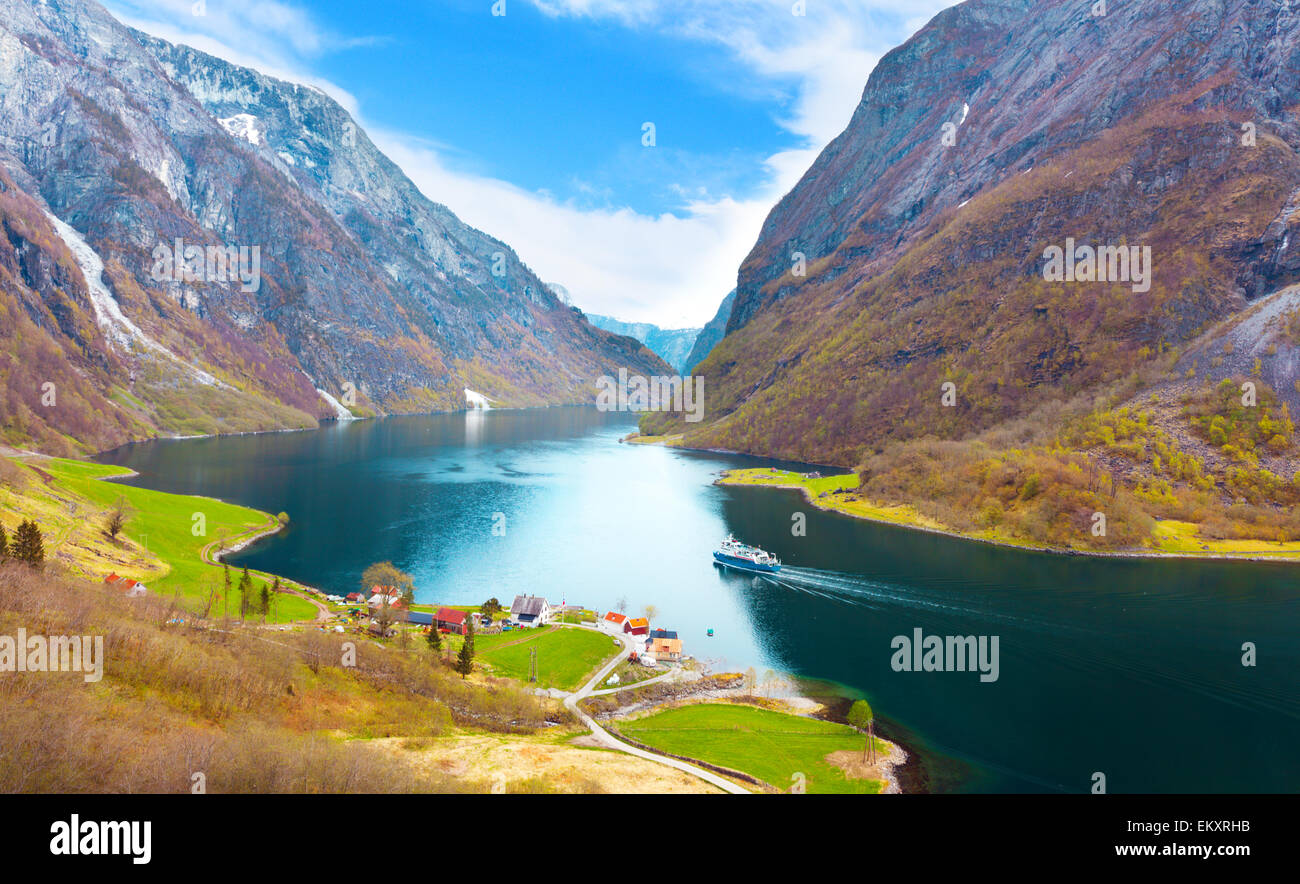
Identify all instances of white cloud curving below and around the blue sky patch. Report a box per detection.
[111,0,950,326]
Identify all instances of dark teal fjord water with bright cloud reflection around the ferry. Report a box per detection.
[103,408,1300,792]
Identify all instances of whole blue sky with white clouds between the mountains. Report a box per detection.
[105,0,948,326]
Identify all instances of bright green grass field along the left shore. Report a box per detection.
[33,458,316,623]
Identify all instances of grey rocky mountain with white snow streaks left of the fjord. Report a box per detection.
[0,0,667,451]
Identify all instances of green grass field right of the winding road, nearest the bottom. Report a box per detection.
[619,703,884,794]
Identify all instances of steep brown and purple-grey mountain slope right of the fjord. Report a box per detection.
[642,0,1300,548]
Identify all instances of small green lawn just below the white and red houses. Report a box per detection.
[467,628,620,690]
